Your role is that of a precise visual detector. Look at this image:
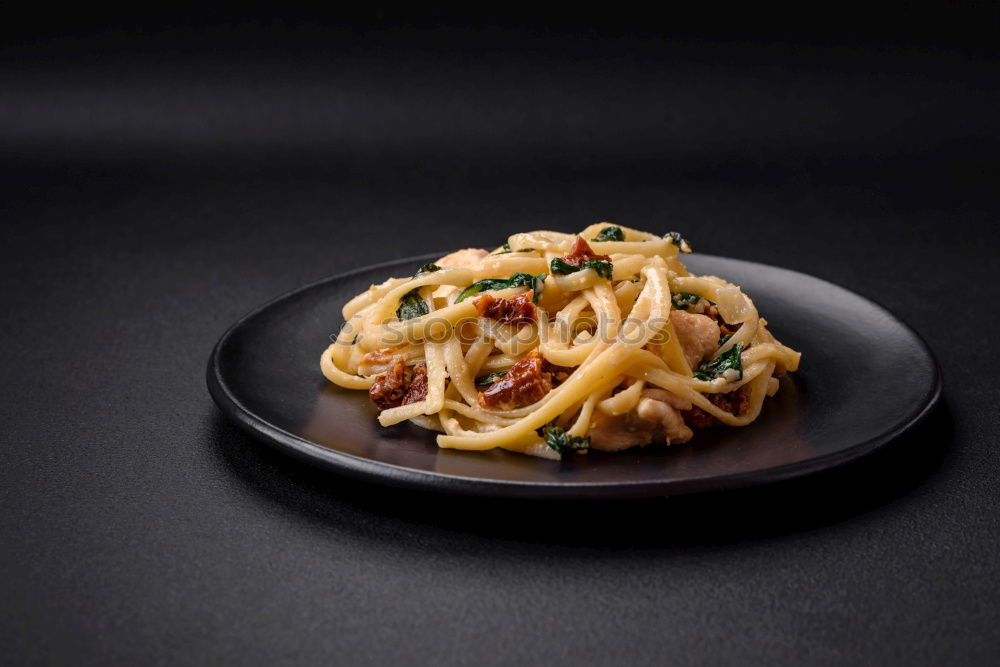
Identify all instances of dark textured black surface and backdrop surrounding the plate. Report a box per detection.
[0,6,1000,665]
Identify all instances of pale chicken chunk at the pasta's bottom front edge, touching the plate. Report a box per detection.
[590,389,694,452]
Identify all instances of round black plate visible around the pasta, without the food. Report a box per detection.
[208,255,940,498]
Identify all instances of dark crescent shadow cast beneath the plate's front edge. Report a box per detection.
[205,398,954,550]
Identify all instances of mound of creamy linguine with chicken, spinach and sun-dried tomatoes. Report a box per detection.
[320,223,800,459]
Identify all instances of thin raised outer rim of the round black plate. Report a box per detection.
[206,253,942,499]
